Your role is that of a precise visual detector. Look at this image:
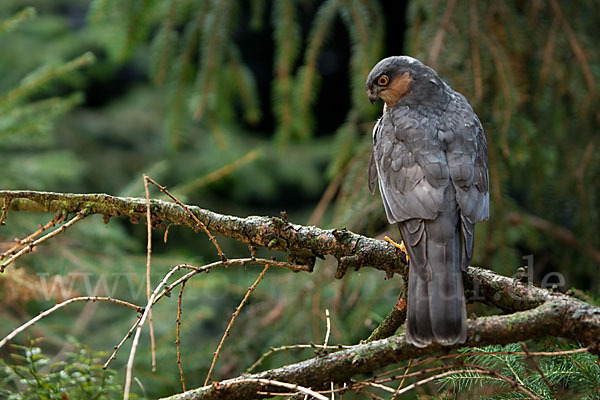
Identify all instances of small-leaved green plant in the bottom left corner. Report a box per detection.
[0,341,120,400]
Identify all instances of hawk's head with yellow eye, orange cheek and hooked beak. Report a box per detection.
[367,56,439,108]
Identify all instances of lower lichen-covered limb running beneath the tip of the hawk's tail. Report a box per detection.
[161,294,600,400]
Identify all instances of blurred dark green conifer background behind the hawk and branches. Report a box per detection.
[0,0,600,398]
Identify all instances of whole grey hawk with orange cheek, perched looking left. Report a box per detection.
[367,56,489,347]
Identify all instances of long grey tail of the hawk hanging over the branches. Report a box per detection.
[399,206,467,347]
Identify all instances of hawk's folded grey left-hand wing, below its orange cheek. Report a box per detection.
[373,107,449,223]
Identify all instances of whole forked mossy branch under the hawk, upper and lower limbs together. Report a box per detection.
[0,191,600,399]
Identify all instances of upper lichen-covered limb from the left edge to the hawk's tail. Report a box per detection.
[0,190,406,278]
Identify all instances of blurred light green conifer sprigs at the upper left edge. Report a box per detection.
[0,8,95,190]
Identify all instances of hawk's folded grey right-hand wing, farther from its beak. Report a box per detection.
[438,95,490,268]
